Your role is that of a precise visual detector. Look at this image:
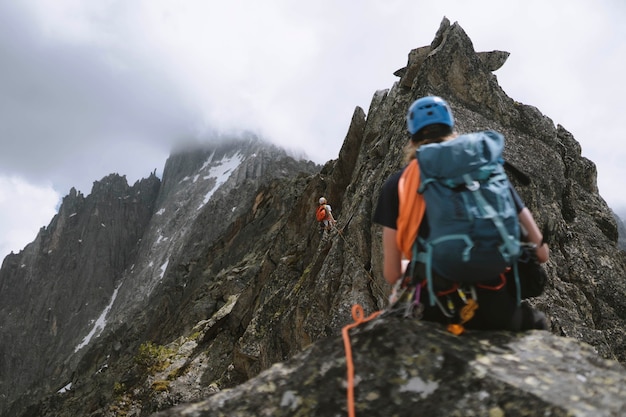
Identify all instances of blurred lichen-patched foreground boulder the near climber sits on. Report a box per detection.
[153,317,626,417]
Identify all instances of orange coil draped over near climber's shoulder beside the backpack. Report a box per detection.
[396,159,426,259]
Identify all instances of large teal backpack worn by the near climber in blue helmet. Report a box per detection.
[413,131,521,305]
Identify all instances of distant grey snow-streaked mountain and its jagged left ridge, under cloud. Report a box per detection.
[0,137,319,416]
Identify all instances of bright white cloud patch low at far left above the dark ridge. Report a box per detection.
[0,176,60,259]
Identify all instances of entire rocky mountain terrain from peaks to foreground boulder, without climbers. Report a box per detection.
[0,18,626,417]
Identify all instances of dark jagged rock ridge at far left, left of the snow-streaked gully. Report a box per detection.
[0,174,161,411]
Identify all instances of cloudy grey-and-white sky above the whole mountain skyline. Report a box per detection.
[0,0,626,259]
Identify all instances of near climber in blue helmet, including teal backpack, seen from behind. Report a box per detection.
[373,96,549,333]
